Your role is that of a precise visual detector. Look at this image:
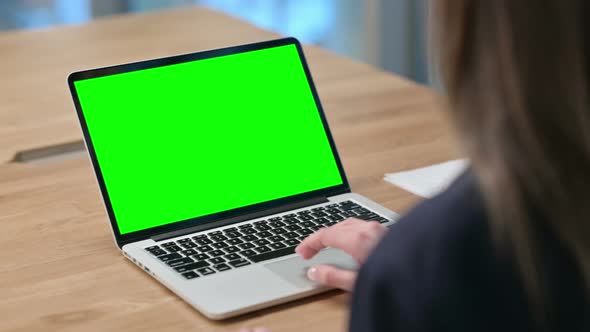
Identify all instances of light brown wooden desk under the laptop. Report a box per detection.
[0,8,456,332]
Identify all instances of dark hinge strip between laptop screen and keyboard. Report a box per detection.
[151,197,329,241]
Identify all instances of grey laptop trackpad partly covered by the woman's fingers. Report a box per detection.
[265,248,358,288]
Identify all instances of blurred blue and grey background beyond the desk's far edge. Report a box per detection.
[0,0,429,84]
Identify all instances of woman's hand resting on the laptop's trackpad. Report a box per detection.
[295,218,387,291]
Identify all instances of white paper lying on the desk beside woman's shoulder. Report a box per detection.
[385,159,469,198]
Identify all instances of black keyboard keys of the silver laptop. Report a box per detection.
[145,201,389,279]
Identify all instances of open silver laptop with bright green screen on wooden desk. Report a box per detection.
[68,38,398,319]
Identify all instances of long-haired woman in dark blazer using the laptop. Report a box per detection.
[243,0,590,332]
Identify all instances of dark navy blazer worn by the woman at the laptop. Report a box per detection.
[350,173,590,332]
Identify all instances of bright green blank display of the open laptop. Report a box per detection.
[74,45,343,234]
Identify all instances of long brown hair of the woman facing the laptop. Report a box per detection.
[431,0,590,322]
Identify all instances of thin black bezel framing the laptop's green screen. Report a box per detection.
[68,37,350,247]
